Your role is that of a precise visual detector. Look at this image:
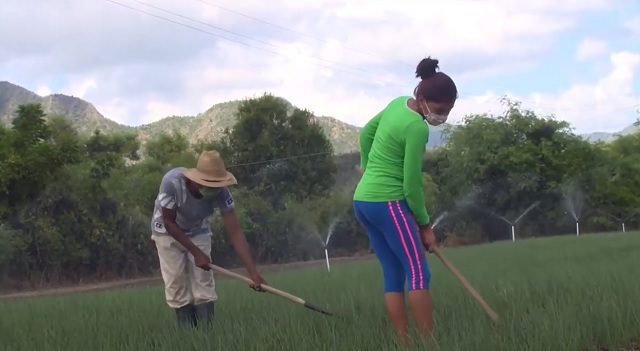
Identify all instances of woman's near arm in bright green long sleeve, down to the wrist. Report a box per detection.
[403,121,429,226]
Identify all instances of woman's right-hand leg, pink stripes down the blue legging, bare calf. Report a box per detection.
[385,201,434,340]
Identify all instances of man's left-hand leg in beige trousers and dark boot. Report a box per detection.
[152,235,196,326]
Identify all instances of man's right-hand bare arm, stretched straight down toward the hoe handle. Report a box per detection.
[218,188,259,277]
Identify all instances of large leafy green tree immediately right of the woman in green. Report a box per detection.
[432,100,594,239]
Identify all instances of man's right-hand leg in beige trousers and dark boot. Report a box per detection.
[188,235,218,323]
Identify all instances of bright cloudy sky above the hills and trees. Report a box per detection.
[0,0,640,133]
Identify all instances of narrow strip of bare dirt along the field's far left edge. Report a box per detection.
[0,255,374,300]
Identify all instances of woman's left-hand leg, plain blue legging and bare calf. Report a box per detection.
[354,201,409,347]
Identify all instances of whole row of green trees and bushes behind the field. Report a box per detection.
[0,94,640,287]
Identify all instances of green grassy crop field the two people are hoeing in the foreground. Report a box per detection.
[0,233,640,351]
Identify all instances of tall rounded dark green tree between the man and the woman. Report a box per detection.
[221,94,336,205]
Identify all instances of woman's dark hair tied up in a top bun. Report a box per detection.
[413,56,458,103]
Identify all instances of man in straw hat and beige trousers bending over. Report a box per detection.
[151,151,265,325]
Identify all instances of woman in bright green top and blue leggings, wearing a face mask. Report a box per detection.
[353,58,458,346]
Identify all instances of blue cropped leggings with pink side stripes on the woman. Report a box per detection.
[353,200,431,293]
